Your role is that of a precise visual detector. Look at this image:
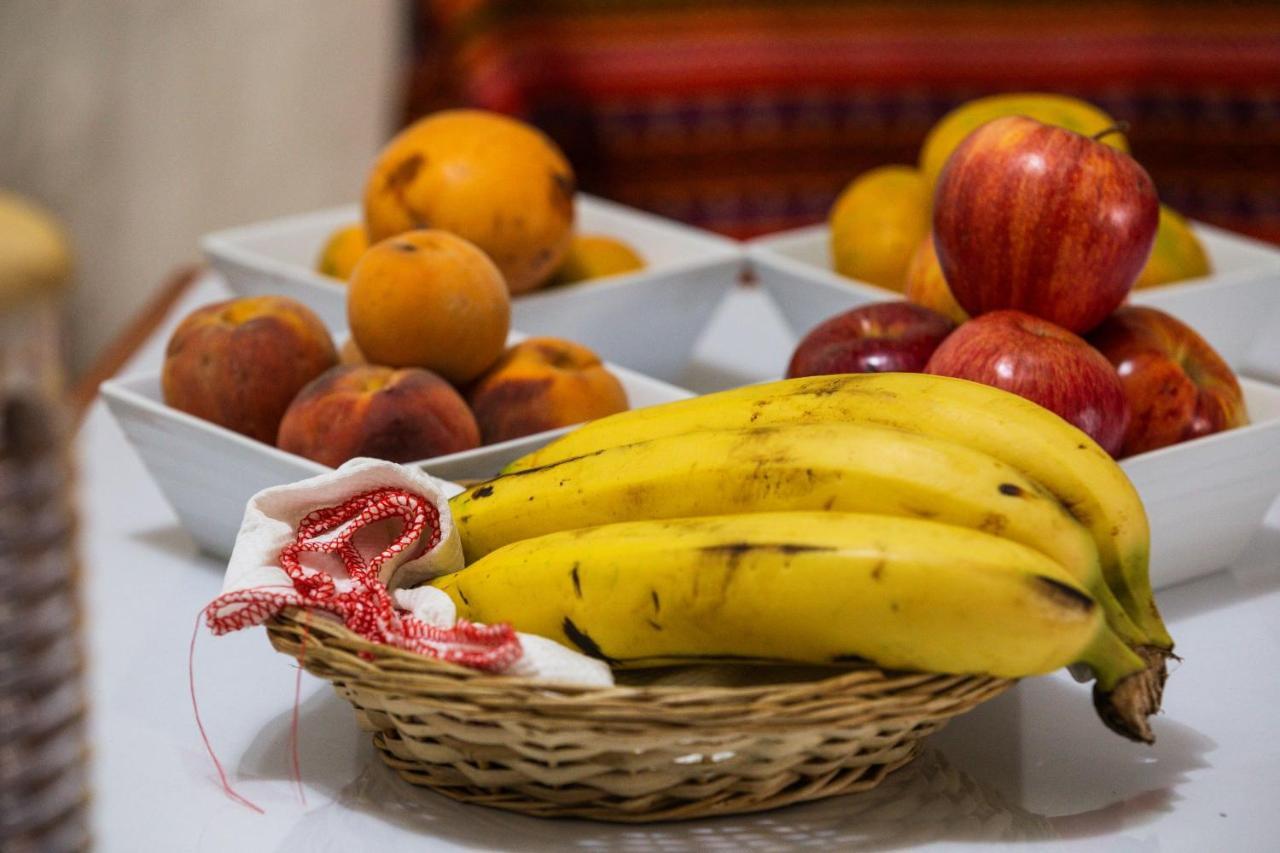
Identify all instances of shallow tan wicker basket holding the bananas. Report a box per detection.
[268,610,1011,822]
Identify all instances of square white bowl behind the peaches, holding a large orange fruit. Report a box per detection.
[201,195,742,382]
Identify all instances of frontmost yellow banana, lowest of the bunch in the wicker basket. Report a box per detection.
[433,512,1151,739]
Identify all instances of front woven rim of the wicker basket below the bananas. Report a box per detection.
[268,596,1015,702]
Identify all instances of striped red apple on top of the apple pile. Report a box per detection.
[933,115,1160,334]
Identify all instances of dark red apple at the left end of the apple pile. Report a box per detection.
[787,301,956,378]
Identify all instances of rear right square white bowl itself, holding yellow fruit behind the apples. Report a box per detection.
[746,223,1280,382]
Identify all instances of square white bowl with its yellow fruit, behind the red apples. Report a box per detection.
[746,95,1280,382]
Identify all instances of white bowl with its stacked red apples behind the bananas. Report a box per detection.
[780,104,1280,585]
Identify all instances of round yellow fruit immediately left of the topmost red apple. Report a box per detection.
[831,165,931,291]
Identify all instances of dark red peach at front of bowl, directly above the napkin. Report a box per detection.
[276,365,480,467]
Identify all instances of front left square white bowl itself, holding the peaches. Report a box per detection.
[102,365,692,557]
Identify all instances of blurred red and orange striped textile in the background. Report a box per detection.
[406,0,1280,242]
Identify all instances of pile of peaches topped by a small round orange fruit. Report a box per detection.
[161,290,628,467]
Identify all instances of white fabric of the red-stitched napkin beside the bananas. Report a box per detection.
[223,459,613,686]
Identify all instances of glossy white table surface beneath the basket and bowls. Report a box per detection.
[77,270,1280,853]
